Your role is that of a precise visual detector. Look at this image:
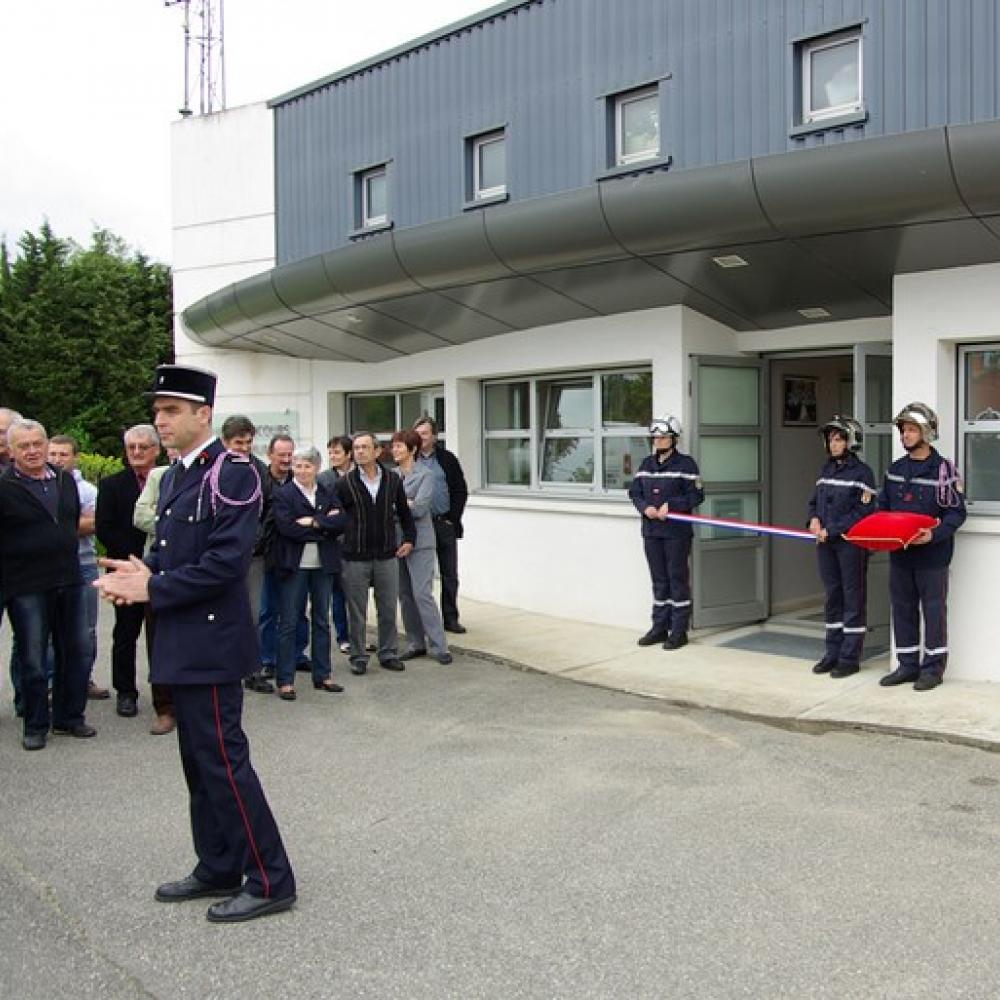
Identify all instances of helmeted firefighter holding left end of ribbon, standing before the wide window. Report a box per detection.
[628,416,705,649]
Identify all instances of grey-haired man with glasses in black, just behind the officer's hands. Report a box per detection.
[97,424,172,718]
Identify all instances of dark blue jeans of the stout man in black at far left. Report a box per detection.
[7,584,89,735]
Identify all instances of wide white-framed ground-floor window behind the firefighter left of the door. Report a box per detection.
[483,370,653,493]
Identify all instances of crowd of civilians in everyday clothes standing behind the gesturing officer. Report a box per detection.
[0,398,468,749]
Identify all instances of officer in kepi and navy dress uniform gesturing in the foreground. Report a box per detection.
[98,365,295,923]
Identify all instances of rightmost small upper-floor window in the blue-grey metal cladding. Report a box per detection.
[799,28,864,125]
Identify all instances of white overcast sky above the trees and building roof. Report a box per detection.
[0,0,493,263]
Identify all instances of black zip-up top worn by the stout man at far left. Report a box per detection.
[0,464,81,597]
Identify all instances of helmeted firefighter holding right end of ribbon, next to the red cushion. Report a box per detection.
[808,415,877,677]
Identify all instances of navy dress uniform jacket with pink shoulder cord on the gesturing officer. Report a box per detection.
[146,440,260,684]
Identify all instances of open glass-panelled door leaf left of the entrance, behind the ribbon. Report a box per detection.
[691,357,768,628]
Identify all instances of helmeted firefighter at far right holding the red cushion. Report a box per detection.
[878,403,965,691]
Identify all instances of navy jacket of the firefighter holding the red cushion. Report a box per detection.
[878,448,965,569]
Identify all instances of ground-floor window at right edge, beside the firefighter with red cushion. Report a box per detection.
[959,344,1000,514]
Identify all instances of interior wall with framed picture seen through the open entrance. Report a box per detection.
[769,353,854,614]
